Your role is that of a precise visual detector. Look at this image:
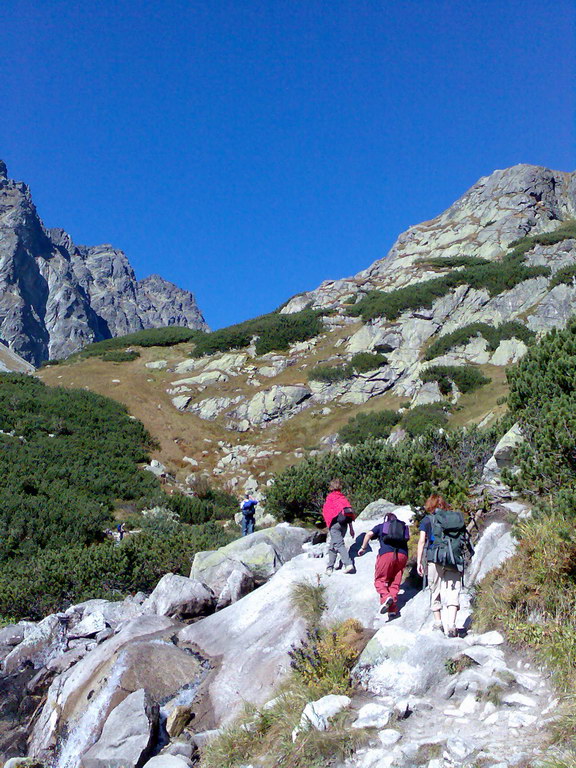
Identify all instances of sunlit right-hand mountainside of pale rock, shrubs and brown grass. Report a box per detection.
[40,166,576,496]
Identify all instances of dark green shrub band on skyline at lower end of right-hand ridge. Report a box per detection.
[193,309,324,357]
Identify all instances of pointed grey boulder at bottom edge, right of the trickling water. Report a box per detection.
[81,688,158,768]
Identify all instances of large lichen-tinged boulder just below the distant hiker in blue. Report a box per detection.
[190,523,313,597]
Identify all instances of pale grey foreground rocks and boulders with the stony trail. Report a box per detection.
[0,484,556,768]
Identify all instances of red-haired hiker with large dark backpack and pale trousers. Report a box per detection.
[417,494,470,637]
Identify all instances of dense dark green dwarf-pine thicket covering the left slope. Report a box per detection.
[0,374,236,619]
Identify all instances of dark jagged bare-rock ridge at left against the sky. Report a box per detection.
[0,161,207,365]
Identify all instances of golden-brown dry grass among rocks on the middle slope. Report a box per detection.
[37,323,507,488]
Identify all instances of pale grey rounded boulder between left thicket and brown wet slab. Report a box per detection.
[142,573,215,618]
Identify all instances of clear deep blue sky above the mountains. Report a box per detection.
[0,0,576,328]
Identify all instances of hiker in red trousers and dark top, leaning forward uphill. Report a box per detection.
[358,512,410,618]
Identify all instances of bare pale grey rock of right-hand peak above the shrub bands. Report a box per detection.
[282,164,576,314]
